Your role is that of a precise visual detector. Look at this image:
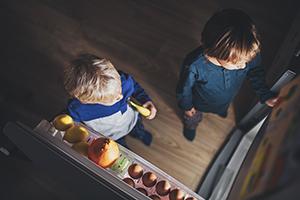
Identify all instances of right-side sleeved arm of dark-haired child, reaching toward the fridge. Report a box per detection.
[247,54,277,103]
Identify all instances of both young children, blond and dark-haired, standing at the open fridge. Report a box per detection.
[65,9,277,145]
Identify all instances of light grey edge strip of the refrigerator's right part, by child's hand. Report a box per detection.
[198,70,296,199]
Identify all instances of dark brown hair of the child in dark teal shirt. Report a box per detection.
[201,9,260,63]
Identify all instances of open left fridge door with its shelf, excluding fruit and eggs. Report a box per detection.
[4,116,203,200]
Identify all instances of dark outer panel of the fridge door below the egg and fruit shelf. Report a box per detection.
[4,123,149,200]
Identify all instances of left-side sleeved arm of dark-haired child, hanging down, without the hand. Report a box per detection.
[176,65,197,111]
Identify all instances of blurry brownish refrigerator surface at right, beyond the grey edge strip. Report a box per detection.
[228,74,300,200]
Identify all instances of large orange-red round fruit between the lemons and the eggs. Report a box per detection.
[88,137,120,168]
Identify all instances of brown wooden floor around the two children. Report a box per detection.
[0,0,297,197]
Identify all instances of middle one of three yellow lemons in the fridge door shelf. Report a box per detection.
[64,125,89,143]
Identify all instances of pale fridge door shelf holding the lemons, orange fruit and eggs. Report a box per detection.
[34,120,203,200]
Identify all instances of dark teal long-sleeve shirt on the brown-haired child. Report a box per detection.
[176,47,276,116]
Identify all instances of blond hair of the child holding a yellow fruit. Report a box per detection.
[64,54,122,104]
